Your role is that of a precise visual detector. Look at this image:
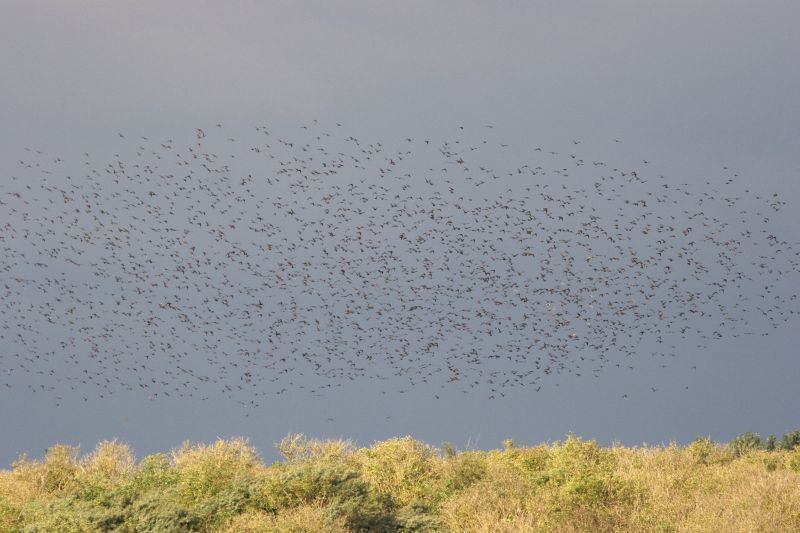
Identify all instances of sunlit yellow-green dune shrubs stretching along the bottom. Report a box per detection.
[0,431,800,533]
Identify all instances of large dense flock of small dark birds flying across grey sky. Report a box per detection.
[0,121,800,407]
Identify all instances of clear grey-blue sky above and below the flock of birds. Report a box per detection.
[0,0,800,465]
